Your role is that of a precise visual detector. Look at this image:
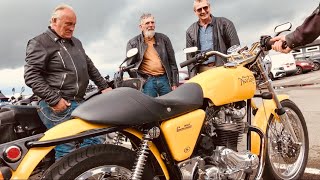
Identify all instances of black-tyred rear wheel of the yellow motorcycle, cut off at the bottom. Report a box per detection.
[42,144,154,180]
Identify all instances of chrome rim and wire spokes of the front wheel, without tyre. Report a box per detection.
[267,102,306,179]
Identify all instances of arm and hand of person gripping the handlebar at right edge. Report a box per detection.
[271,4,320,53]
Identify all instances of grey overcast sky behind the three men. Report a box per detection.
[0,0,319,95]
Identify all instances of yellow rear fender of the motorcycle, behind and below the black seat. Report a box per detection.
[12,119,169,179]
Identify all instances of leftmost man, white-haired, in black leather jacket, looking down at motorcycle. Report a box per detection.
[24,4,111,159]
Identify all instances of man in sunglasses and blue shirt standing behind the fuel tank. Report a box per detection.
[186,0,240,77]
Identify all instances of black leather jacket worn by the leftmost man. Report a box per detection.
[24,29,108,106]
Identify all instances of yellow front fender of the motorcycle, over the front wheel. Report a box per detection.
[251,95,289,155]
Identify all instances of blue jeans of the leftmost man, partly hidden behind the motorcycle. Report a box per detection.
[38,100,103,159]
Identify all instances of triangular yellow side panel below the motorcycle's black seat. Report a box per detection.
[161,110,205,161]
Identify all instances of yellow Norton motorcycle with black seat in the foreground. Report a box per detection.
[0,24,309,180]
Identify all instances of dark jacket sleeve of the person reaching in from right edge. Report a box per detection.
[286,4,320,49]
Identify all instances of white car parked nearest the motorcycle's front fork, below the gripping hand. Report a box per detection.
[263,56,286,80]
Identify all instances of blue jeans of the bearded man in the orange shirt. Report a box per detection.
[143,75,172,97]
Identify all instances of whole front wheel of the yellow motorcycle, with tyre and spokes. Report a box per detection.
[264,100,309,180]
